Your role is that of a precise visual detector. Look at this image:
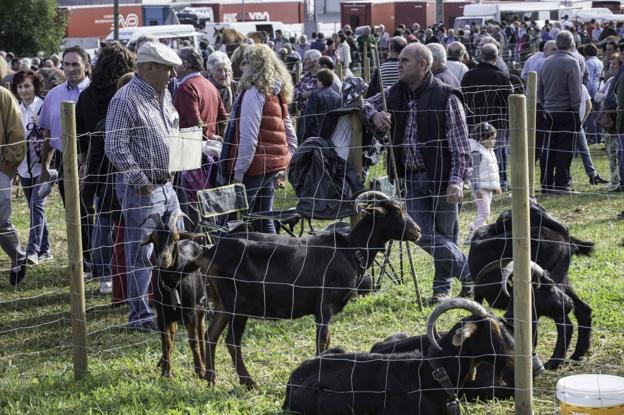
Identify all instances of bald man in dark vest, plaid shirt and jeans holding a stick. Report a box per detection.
[363,44,473,303]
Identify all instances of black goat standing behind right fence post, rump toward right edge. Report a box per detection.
[468,203,594,369]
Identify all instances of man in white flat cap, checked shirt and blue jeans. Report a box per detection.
[105,42,183,329]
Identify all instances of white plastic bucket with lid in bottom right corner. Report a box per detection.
[557,375,624,415]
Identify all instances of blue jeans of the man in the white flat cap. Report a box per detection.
[115,174,184,325]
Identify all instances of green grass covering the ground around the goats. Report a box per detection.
[0,146,624,414]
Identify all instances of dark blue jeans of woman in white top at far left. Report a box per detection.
[20,176,50,255]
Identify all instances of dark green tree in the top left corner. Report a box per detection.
[0,0,67,56]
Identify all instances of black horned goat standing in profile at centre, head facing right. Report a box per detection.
[196,191,420,387]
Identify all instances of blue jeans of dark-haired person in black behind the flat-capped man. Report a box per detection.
[91,197,113,282]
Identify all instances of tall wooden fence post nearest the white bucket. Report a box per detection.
[509,95,533,415]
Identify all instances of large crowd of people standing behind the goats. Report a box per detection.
[0,18,624,329]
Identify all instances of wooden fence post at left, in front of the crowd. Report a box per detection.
[61,101,87,379]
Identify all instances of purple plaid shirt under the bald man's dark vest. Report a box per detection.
[363,92,472,186]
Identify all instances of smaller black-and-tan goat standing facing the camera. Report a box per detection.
[141,214,207,377]
